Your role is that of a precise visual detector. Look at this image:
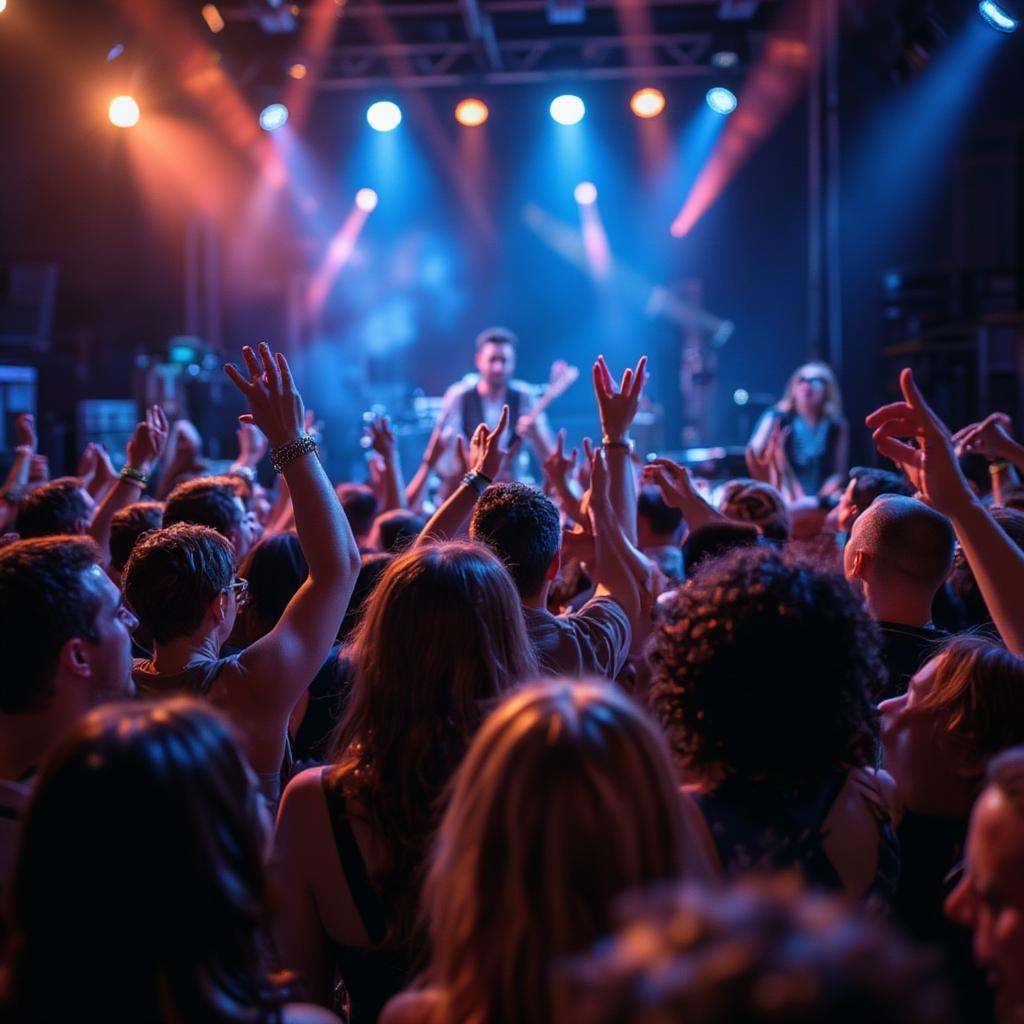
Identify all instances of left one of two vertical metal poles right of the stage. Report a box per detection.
[807,2,825,359]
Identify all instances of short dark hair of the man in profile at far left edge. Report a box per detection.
[0,537,101,715]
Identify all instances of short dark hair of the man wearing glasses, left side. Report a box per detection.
[124,522,234,642]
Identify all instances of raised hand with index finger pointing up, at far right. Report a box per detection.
[864,370,973,516]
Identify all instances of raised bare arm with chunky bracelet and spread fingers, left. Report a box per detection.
[224,344,359,724]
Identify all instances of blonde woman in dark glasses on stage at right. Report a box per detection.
[748,362,849,495]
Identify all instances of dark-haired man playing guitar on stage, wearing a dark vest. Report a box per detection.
[434,327,554,462]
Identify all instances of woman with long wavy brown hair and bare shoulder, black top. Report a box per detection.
[271,543,536,1024]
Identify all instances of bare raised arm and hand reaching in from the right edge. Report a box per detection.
[865,370,1024,655]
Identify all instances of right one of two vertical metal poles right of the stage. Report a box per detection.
[823,0,843,377]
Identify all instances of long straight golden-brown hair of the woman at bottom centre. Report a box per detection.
[424,681,685,1024]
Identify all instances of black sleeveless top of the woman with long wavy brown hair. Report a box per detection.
[321,769,413,1024]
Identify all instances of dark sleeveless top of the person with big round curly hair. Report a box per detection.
[694,771,899,906]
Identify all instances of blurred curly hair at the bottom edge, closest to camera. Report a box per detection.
[556,877,953,1024]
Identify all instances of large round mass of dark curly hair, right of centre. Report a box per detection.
[650,548,884,799]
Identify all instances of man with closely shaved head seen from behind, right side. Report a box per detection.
[843,495,955,696]
